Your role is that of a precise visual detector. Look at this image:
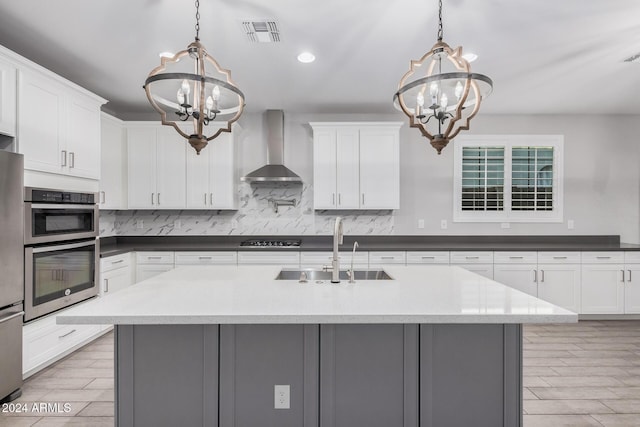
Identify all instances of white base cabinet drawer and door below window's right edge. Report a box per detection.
[538,252,581,313]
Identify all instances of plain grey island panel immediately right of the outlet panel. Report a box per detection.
[320,324,418,427]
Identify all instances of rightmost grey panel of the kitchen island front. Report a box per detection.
[420,324,522,427]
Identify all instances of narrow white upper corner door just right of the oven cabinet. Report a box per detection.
[98,114,127,209]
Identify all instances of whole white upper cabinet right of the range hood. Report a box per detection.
[310,122,402,209]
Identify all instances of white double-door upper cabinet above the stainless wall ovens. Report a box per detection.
[17,68,104,180]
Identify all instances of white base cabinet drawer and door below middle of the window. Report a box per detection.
[493,252,538,297]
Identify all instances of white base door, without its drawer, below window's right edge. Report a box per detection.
[538,263,580,313]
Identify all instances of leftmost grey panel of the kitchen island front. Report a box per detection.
[115,325,219,427]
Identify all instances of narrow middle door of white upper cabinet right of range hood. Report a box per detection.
[336,128,360,209]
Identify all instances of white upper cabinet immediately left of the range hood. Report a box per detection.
[186,126,240,209]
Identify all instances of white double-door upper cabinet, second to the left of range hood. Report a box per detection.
[127,124,187,209]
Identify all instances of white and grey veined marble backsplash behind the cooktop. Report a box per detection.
[100,183,394,237]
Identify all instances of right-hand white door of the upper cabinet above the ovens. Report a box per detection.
[67,97,100,179]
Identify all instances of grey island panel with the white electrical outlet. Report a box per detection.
[220,325,319,427]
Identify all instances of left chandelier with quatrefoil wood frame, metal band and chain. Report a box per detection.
[143,0,244,154]
